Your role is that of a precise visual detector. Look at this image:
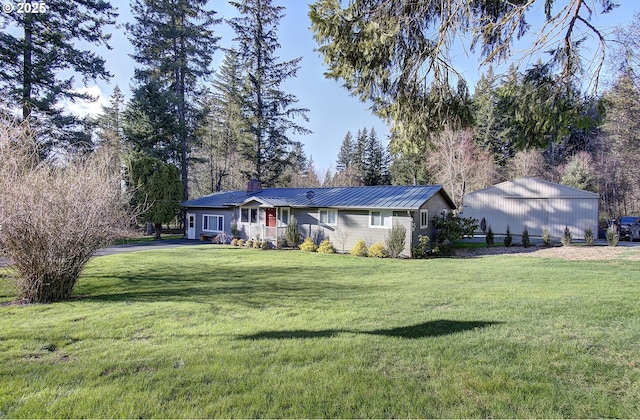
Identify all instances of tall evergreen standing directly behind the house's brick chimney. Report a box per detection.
[230,0,309,185]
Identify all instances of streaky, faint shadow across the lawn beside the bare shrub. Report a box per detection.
[81,264,372,308]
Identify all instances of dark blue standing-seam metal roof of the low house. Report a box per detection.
[181,185,455,210]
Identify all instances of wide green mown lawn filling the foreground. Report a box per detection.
[0,246,640,418]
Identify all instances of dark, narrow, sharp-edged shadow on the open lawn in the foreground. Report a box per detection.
[239,319,501,340]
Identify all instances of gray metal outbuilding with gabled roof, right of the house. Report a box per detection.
[461,177,600,239]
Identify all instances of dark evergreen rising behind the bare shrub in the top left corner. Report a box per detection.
[0,0,117,155]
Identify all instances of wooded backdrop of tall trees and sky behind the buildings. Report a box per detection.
[0,0,640,225]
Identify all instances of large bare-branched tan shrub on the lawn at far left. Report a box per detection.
[0,120,132,303]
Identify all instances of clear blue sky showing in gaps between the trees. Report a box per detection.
[70,0,640,170]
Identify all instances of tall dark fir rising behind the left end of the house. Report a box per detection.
[127,0,220,199]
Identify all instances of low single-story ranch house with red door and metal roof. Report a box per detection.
[181,181,455,256]
